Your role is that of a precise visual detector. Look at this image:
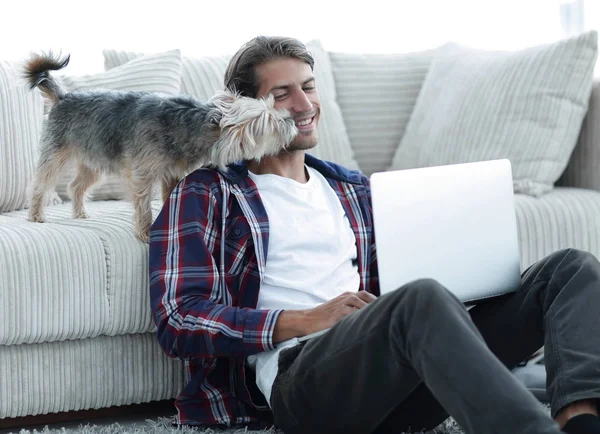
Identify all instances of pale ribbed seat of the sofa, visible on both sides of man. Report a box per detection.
[0,187,600,345]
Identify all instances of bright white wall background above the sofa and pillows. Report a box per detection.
[0,0,600,74]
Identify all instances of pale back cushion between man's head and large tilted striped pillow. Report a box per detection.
[329,50,437,176]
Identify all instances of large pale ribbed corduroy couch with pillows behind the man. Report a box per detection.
[0,32,600,419]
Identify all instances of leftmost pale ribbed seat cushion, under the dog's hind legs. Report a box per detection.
[0,212,109,345]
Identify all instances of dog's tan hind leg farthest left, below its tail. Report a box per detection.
[28,145,71,223]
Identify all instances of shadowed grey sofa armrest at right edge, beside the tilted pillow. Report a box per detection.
[557,78,600,191]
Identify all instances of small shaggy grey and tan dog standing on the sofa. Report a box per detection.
[24,52,298,242]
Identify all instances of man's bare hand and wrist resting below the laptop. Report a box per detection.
[273,291,377,344]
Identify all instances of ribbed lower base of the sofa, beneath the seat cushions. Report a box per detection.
[0,333,184,418]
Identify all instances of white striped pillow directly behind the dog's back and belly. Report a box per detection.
[56,50,181,200]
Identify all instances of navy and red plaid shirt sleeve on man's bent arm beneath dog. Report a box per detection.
[149,177,282,359]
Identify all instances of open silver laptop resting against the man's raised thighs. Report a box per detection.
[371,159,521,304]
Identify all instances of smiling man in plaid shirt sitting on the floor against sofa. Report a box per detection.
[150,37,600,434]
